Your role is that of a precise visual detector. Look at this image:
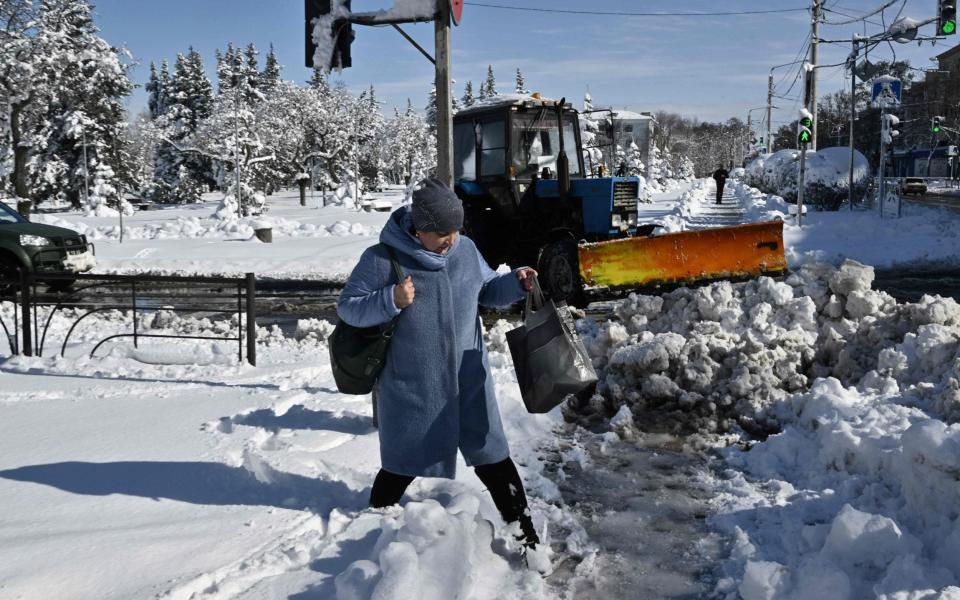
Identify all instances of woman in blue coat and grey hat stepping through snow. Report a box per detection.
[337,178,539,546]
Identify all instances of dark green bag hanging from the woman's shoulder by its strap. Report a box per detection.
[327,246,404,395]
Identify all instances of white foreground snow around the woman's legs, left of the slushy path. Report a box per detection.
[0,312,568,600]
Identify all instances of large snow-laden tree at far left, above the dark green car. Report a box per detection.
[14,0,133,206]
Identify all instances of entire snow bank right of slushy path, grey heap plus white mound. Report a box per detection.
[578,261,960,600]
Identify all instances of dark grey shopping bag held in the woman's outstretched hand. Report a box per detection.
[507,278,597,413]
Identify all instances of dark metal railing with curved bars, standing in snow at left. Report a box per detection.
[0,272,257,365]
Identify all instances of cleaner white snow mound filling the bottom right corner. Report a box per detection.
[713,378,960,600]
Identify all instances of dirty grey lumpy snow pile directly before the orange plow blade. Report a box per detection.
[580,261,960,433]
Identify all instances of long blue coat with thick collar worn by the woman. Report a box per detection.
[337,207,525,479]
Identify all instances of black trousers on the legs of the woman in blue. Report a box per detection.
[370,458,540,546]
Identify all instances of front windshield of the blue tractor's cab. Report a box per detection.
[513,110,580,179]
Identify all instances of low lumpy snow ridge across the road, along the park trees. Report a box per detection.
[35,215,380,241]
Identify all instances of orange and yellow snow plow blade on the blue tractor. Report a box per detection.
[580,221,787,288]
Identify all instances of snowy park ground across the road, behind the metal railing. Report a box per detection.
[34,188,404,279]
